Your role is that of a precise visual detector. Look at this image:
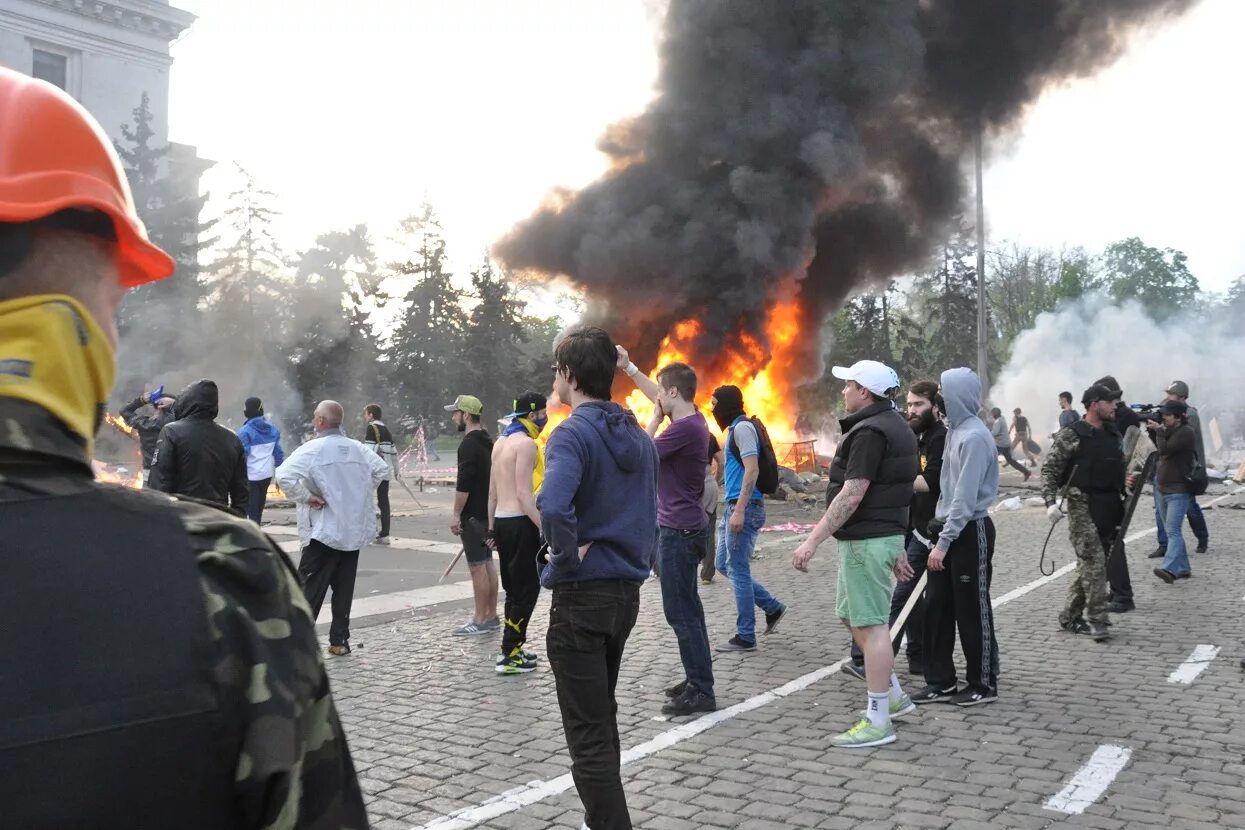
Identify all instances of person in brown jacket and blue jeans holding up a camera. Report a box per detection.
[1145,399,1196,585]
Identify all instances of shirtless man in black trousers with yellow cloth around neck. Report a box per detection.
[488,392,549,674]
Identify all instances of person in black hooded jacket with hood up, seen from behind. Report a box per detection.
[148,381,250,516]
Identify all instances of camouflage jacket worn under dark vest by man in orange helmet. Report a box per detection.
[0,398,369,830]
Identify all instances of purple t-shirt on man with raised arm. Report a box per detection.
[655,412,708,530]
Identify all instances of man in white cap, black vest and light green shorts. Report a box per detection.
[792,361,919,748]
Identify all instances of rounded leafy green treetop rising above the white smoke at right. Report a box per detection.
[1098,236,1198,321]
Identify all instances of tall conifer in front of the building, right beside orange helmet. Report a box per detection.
[116,92,215,343]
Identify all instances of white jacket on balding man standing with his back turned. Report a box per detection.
[276,429,388,550]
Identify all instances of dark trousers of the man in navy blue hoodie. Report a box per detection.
[545,580,640,830]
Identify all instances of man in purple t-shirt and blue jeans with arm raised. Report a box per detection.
[618,346,717,717]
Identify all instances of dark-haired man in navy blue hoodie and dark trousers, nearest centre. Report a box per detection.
[537,327,657,830]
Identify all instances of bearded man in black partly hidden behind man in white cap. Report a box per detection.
[843,381,946,679]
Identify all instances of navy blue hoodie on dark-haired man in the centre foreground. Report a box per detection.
[537,401,657,587]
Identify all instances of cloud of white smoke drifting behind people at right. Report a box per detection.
[990,296,1245,459]
